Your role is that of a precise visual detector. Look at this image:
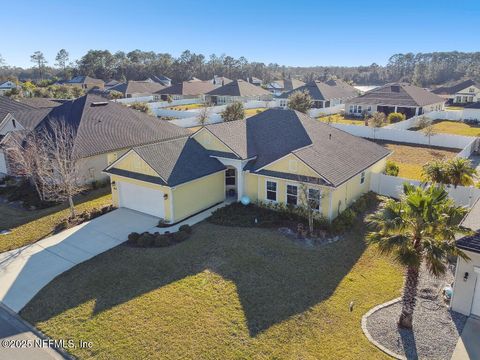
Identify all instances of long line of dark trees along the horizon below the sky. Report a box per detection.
[0,49,480,87]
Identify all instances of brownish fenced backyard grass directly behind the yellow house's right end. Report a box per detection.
[377,141,459,180]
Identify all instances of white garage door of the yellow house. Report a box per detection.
[117,181,165,218]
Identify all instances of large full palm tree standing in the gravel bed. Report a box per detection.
[367,184,470,328]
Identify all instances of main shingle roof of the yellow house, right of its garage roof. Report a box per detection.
[205,109,390,186]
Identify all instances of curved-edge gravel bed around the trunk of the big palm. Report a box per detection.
[366,268,467,360]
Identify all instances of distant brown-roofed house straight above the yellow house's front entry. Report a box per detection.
[205,80,273,105]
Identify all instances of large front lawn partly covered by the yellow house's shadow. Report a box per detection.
[21,219,402,359]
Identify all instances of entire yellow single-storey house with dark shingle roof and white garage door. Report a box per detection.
[105,109,390,223]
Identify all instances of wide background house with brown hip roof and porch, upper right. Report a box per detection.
[345,83,445,118]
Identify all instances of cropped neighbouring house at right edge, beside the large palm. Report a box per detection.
[451,199,480,316]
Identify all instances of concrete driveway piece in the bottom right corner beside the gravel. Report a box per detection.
[452,316,480,360]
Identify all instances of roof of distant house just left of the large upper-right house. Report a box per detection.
[279,80,358,100]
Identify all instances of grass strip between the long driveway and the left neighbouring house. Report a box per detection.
[0,188,112,252]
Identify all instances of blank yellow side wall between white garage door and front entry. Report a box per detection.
[173,171,225,222]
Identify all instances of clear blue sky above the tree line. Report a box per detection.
[0,0,480,66]
